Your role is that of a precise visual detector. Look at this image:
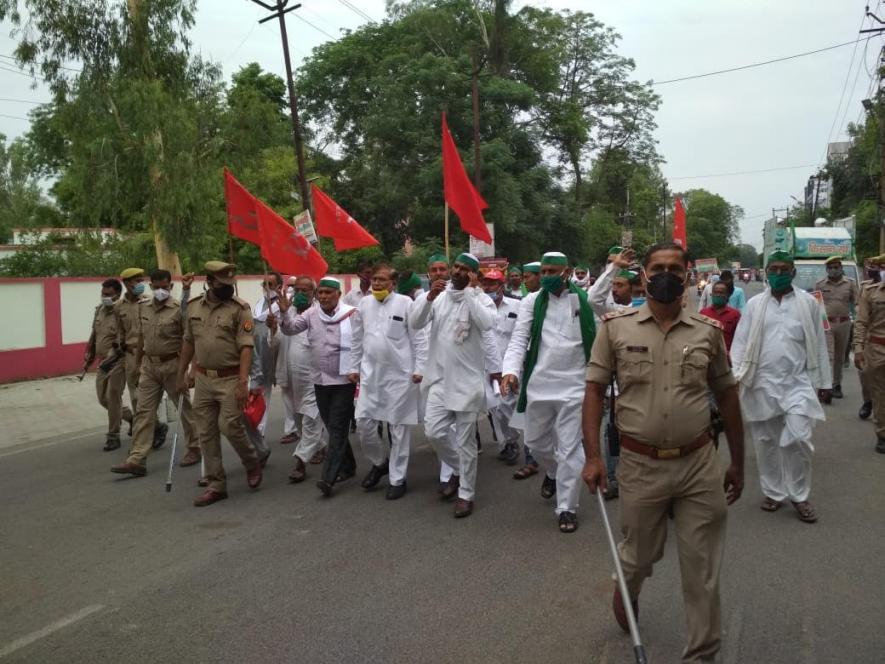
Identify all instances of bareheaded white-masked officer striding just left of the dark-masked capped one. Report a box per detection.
[111,270,201,477]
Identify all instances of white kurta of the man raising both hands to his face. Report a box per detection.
[409,286,495,413]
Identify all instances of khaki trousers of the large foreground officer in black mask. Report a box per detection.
[617,445,727,663]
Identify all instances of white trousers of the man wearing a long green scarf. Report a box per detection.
[525,401,584,514]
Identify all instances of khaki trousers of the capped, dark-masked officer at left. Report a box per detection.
[193,373,258,493]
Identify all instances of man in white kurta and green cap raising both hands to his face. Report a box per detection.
[410,254,495,518]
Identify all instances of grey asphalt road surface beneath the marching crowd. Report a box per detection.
[0,287,885,664]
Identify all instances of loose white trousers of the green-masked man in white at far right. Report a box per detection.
[747,413,815,503]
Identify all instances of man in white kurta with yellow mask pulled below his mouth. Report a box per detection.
[351,265,427,500]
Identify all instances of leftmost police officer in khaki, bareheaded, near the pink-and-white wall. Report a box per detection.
[83,279,132,452]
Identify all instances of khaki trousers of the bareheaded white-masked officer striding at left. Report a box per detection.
[128,356,200,466]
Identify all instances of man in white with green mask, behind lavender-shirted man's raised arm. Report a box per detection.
[271,277,325,484]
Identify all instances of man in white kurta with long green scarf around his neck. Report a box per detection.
[503,252,592,533]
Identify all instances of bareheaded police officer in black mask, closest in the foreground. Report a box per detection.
[583,243,744,662]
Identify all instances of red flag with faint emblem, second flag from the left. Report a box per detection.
[255,199,329,280]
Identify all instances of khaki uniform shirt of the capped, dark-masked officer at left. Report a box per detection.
[184,293,255,371]
